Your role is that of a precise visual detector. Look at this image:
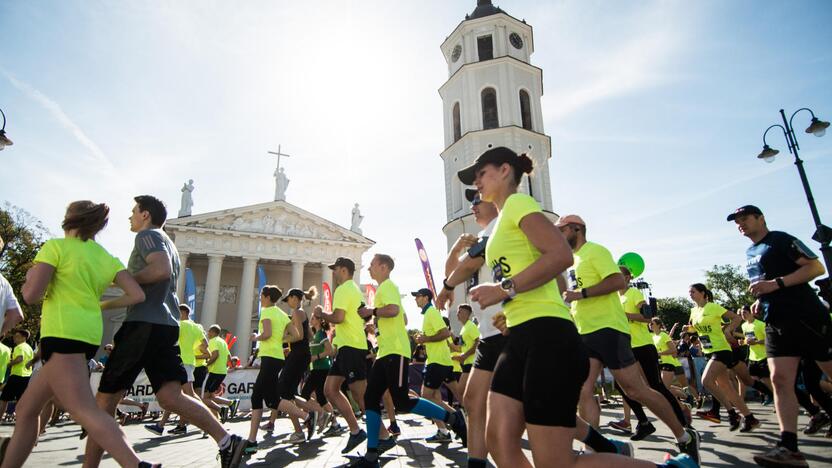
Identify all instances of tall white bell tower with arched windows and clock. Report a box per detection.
[439,0,554,252]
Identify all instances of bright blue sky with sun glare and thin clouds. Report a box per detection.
[0,0,832,322]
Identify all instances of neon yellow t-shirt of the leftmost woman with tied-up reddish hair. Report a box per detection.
[35,237,124,346]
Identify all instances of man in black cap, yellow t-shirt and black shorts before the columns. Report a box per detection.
[314,257,367,453]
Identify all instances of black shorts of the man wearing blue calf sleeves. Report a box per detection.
[364,354,419,413]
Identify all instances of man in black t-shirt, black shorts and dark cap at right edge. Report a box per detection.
[728,205,832,466]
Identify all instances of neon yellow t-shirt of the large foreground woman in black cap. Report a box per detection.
[485,193,572,327]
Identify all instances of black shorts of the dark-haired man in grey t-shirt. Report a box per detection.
[98,322,188,393]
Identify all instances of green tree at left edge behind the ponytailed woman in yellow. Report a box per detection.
[0,202,49,336]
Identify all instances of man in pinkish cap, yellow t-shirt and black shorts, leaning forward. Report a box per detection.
[555,215,699,463]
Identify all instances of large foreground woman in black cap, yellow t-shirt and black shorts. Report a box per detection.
[458,147,696,467]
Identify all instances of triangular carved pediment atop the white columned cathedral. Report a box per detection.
[166,201,374,245]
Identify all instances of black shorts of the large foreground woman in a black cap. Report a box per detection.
[490,317,589,427]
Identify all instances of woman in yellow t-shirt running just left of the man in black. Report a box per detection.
[689,283,760,432]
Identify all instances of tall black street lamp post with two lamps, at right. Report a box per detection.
[757,107,832,288]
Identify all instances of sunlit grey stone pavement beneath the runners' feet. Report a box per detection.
[0,403,832,468]
